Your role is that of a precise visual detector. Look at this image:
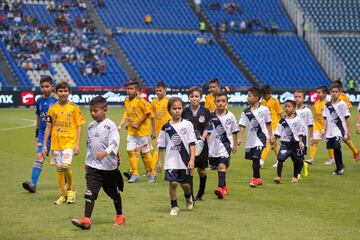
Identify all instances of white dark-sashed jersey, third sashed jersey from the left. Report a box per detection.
[239,105,271,148]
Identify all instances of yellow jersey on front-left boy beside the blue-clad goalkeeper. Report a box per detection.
[48,102,85,150]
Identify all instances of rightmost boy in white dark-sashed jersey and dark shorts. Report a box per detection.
[321,84,350,176]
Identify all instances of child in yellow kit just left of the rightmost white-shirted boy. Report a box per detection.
[305,86,335,165]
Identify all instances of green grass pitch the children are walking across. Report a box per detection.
[0,108,360,240]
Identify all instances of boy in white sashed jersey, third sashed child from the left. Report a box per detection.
[238,87,275,188]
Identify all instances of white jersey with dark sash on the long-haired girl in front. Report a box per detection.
[158,119,196,170]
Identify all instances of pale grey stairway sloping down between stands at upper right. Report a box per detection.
[281,0,346,81]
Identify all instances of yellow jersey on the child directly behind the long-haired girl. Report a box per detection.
[151,97,171,133]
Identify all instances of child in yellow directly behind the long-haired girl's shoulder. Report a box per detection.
[151,81,171,174]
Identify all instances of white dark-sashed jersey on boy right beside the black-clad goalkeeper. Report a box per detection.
[208,111,239,158]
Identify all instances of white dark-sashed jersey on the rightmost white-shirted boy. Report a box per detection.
[323,100,350,138]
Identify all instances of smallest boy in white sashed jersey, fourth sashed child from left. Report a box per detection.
[274,99,307,184]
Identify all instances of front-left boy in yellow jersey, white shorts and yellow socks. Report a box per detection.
[42,82,85,205]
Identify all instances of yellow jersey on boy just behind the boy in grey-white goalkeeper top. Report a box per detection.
[123,96,151,137]
